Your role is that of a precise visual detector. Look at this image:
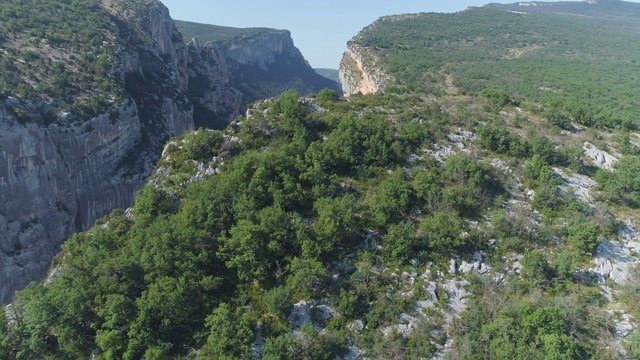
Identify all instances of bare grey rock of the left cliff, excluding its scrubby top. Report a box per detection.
[0,0,241,303]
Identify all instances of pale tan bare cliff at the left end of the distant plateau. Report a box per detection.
[340,43,389,96]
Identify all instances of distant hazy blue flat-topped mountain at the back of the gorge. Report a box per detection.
[176,21,341,103]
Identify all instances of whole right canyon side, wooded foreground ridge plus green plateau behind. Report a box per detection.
[0,1,640,360]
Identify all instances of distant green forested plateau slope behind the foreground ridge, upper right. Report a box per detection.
[353,2,640,129]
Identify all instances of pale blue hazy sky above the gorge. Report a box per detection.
[161,0,640,69]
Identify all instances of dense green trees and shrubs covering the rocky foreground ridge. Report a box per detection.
[0,90,628,359]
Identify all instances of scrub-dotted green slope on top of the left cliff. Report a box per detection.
[0,0,120,122]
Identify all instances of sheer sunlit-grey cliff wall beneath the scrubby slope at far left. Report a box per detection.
[0,102,145,302]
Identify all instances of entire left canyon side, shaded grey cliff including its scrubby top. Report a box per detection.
[0,0,240,303]
